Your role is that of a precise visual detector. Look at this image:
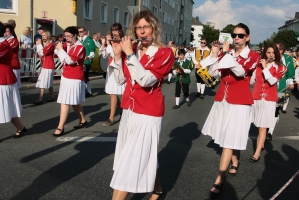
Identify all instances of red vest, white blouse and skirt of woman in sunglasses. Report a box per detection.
[201,46,259,150]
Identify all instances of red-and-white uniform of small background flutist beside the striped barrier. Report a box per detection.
[36,42,55,88]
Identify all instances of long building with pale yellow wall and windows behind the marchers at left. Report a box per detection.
[0,0,194,44]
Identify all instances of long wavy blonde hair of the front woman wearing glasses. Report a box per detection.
[128,10,164,47]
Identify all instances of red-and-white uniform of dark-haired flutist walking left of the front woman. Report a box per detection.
[55,41,85,105]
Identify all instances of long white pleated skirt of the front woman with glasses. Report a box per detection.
[110,109,162,193]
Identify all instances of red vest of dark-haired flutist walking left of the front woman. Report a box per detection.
[62,42,85,81]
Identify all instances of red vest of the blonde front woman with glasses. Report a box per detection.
[121,48,175,117]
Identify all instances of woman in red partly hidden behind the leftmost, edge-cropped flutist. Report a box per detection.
[4,24,21,89]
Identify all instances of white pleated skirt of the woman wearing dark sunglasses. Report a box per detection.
[202,99,251,150]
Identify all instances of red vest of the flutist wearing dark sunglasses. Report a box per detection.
[215,49,260,105]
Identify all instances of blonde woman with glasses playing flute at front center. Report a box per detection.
[109,10,174,200]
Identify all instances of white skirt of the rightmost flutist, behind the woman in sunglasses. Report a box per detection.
[252,99,277,128]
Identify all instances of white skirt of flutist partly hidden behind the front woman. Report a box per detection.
[105,67,126,95]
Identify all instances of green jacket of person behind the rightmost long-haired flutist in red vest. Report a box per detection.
[277,54,295,92]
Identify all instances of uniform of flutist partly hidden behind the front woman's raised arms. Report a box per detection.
[99,45,126,95]
